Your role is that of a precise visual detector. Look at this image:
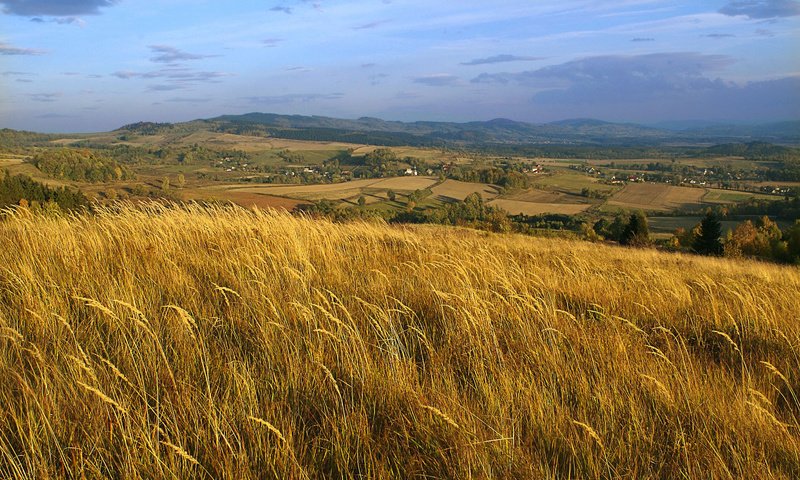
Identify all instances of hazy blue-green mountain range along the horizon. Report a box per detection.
[120,113,800,146]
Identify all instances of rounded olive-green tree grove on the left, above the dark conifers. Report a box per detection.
[30,148,134,182]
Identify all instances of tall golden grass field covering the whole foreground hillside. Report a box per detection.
[0,204,800,479]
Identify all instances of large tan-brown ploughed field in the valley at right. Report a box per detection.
[607,183,706,210]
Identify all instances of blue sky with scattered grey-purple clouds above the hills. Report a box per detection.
[0,0,800,132]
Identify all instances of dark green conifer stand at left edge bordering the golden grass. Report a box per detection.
[0,171,89,211]
